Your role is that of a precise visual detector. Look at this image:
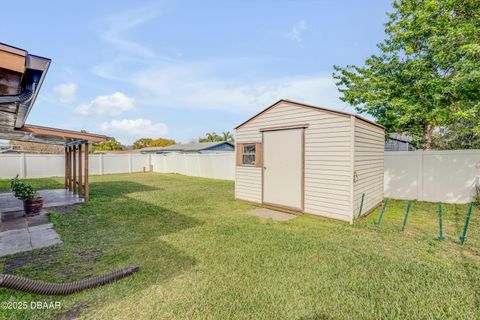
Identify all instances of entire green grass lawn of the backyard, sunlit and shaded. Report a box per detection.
[0,173,480,319]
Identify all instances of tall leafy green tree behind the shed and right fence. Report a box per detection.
[334,0,480,149]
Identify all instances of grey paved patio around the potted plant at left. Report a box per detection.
[0,189,84,256]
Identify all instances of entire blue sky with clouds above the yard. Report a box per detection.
[0,0,391,144]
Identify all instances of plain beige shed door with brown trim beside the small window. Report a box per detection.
[263,129,304,210]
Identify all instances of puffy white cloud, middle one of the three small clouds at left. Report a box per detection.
[74,92,135,116]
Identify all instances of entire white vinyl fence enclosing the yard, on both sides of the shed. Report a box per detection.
[0,150,480,203]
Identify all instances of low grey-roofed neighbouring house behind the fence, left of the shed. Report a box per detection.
[140,141,235,154]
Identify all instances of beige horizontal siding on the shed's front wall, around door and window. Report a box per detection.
[235,102,352,221]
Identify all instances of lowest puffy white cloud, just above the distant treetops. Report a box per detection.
[101,118,168,144]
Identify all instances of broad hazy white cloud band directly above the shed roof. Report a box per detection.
[130,65,347,113]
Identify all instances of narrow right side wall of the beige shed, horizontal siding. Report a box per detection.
[354,118,385,215]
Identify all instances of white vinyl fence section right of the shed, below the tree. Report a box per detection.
[384,150,480,203]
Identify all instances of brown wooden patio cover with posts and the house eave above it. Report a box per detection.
[0,43,108,201]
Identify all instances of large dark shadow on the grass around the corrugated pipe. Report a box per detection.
[0,181,202,318]
